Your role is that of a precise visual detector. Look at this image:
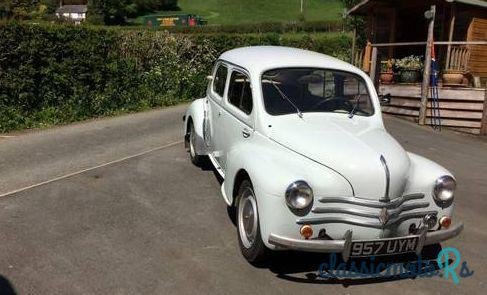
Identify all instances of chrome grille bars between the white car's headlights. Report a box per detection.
[297,194,436,229]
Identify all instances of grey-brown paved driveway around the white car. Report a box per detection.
[0,106,487,295]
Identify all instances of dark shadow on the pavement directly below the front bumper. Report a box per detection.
[257,245,453,287]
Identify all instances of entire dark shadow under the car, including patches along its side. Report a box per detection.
[200,158,453,287]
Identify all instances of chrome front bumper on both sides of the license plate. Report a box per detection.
[269,223,463,261]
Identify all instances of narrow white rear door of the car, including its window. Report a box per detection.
[204,61,229,166]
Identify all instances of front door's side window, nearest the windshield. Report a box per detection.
[228,72,253,115]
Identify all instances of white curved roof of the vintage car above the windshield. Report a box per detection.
[220,46,362,74]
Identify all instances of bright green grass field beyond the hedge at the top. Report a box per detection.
[137,0,344,25]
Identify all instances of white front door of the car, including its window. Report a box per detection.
[221,67,254,171]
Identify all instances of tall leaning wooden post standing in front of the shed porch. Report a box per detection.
[419,5,436,125]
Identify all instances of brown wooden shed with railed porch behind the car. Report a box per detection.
[347,0,487,134]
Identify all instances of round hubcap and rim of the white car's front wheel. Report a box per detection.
[238,188,258,248]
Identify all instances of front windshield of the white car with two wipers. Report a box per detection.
[262,68,374,117]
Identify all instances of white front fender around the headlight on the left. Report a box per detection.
[223,133,353,247]
